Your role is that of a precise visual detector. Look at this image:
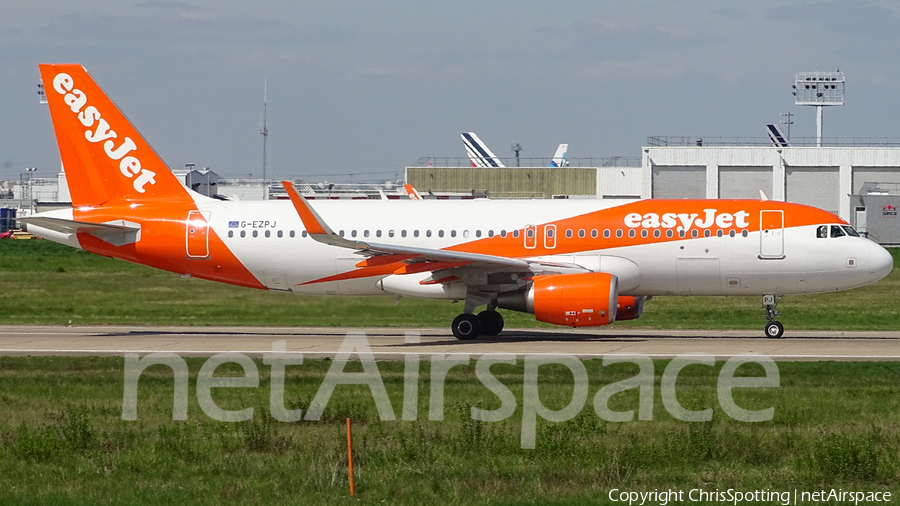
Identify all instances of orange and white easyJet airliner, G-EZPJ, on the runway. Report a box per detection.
[22,65,893,339]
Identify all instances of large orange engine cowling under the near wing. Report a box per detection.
[528,272,619,327]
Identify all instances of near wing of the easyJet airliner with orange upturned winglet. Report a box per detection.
[282,181,587,272]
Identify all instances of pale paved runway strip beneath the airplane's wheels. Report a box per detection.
[0,326,900,361]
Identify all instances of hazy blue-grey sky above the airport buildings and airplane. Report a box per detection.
[0,0,900,182]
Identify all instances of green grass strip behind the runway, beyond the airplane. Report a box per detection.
[0,241,900,330]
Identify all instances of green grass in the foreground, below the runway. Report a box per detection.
[0,357,900,505]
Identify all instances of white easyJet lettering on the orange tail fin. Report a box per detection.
[53,73,156,193]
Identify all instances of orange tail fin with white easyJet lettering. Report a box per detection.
[40,64,192,206]
